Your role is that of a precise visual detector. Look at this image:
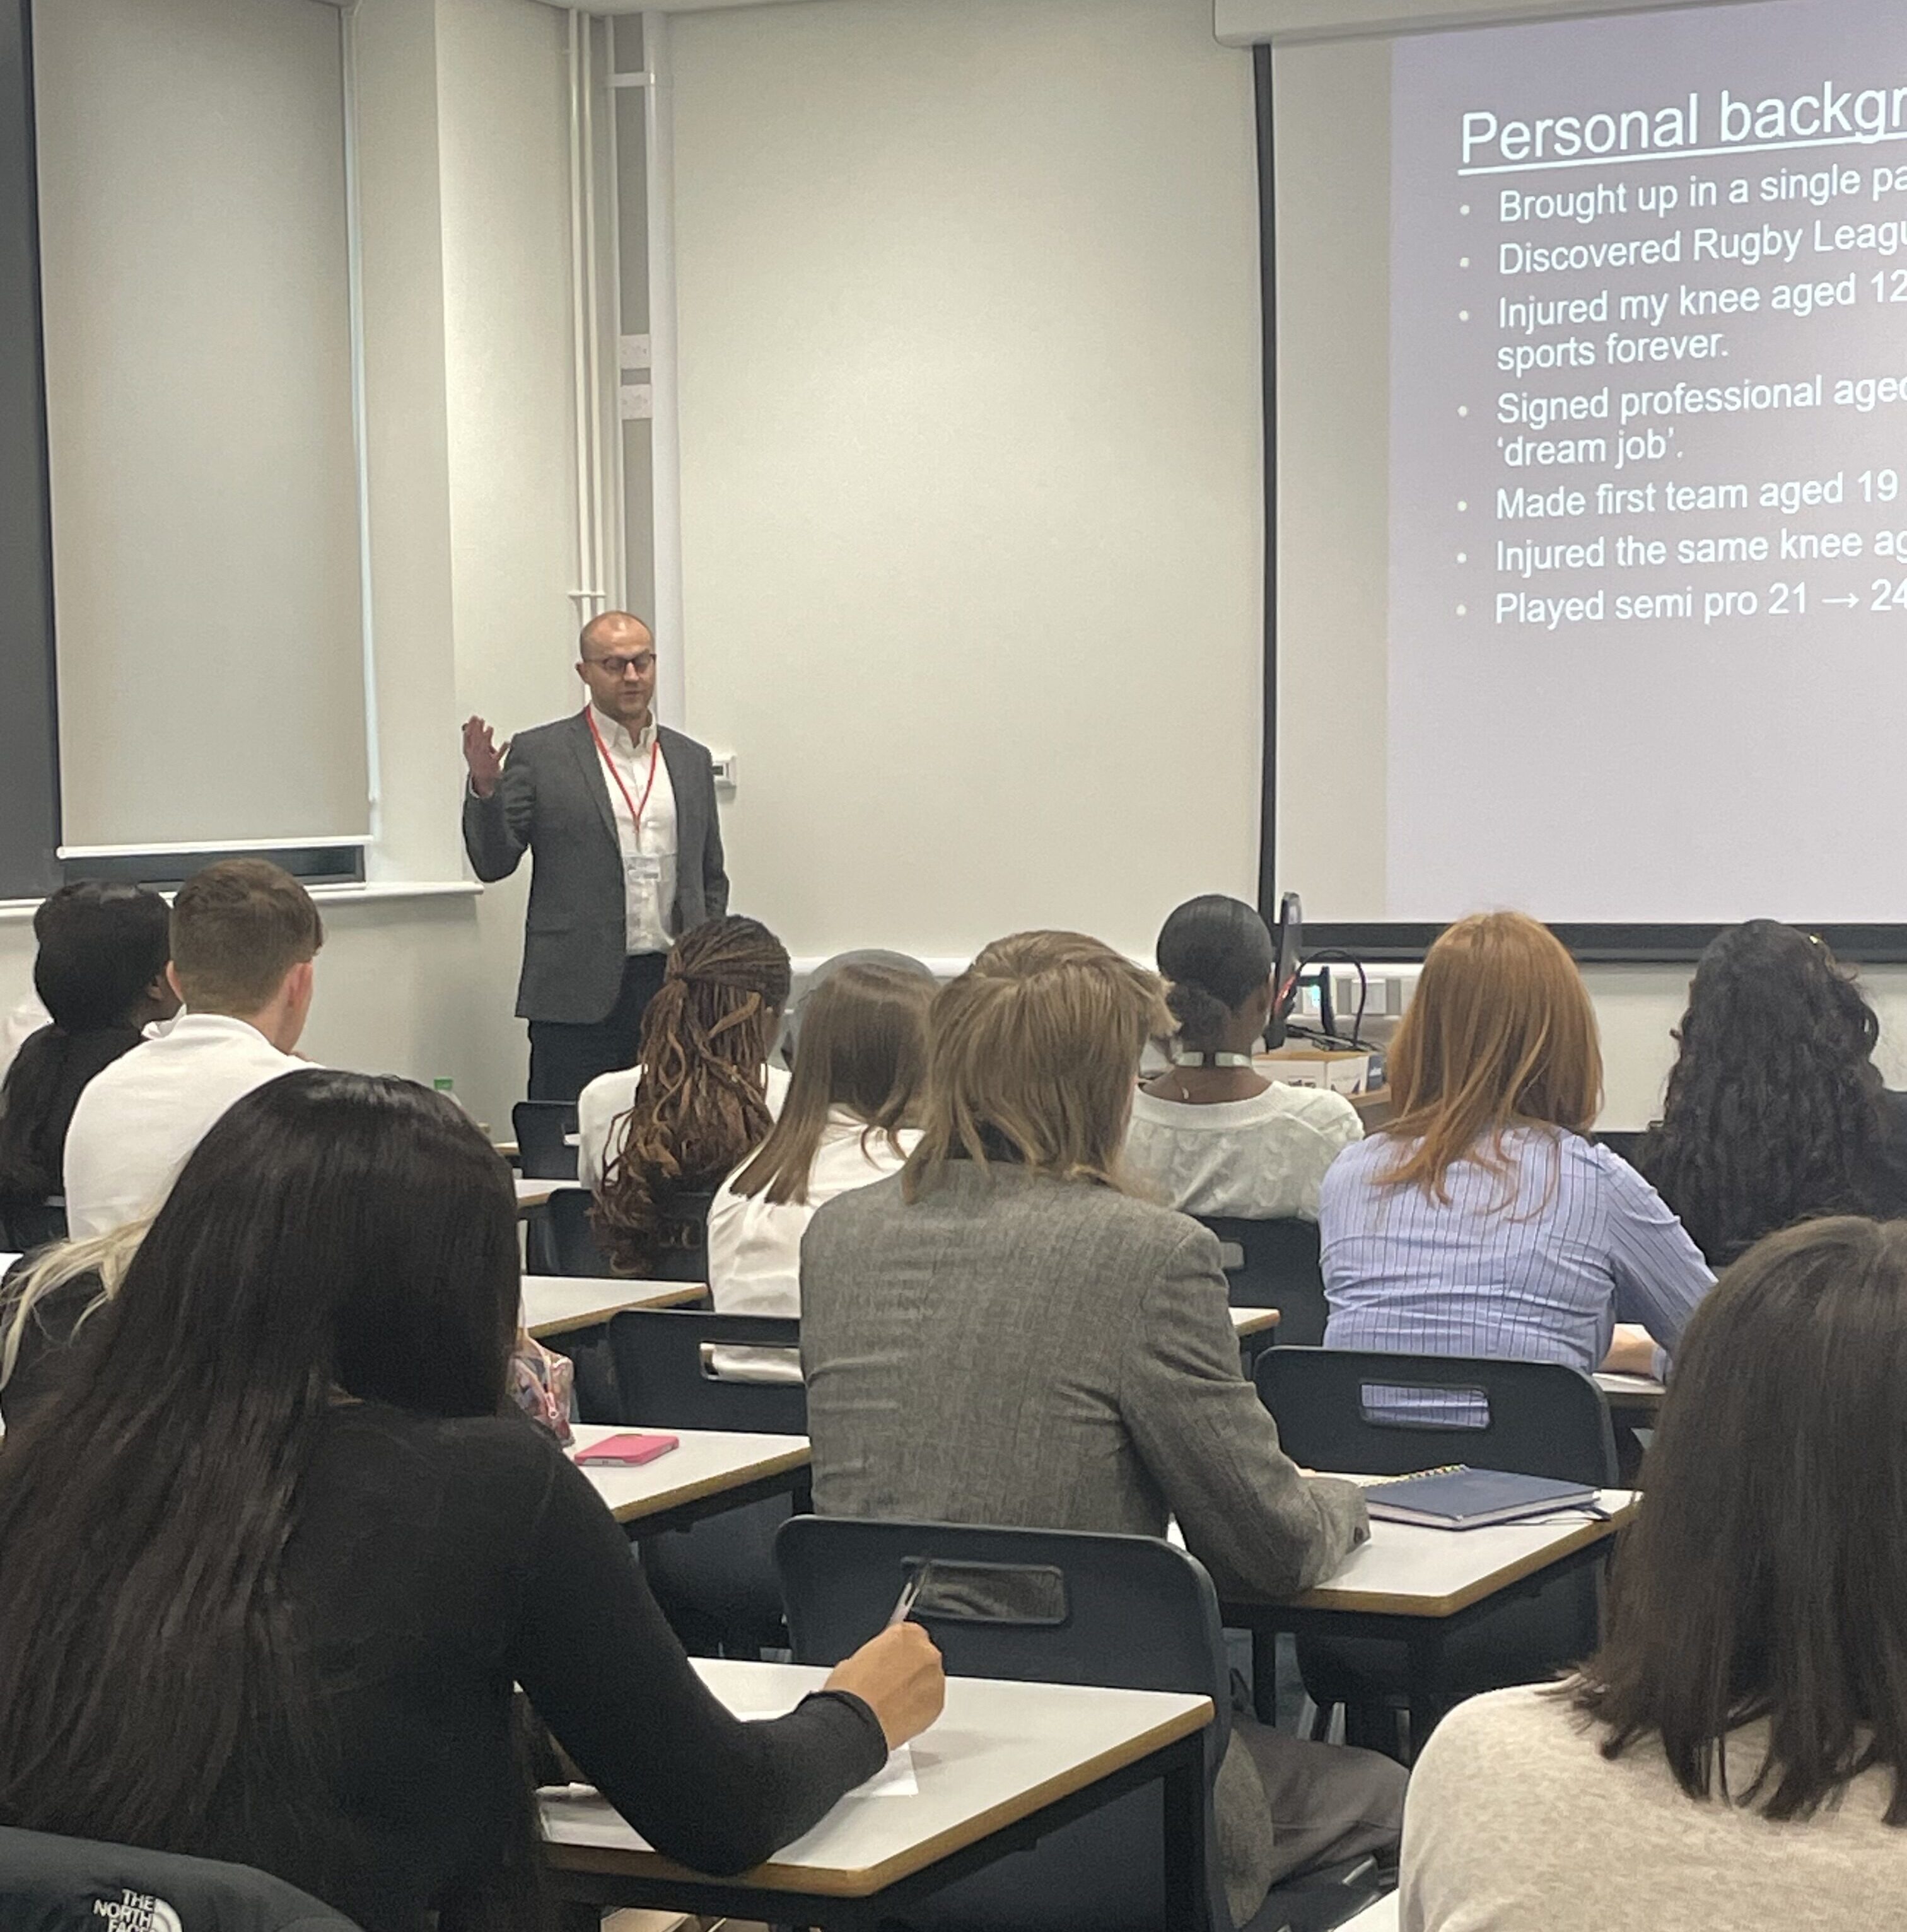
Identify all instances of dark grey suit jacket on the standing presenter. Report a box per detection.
[464,711,728,1024]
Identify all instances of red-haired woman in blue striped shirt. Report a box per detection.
[1318,912,1714,1374]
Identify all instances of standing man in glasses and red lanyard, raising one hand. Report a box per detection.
[464,610,728,1099]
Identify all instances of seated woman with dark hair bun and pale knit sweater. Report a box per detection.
[1126,893,1364,1221]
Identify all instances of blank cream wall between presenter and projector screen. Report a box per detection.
[670,0,1264,955]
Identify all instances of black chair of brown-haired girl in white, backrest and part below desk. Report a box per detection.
[609,1308,808,1656]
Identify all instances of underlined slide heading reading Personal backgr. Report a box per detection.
[1459,81,1907,174]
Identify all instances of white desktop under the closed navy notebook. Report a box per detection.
[1291,1489,1636,1617]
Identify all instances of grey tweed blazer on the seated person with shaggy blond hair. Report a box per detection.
[802,1161,1370,1916]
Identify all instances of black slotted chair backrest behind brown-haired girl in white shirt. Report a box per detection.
[609,1308,803,1429]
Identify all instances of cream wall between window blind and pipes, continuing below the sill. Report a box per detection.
[0,0,580,1130]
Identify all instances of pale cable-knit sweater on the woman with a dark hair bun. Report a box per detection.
[1126,1080,1364,1221]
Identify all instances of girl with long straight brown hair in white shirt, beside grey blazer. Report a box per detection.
[709,964,933,1382]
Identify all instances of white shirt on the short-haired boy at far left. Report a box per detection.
[66,1013,305,1238]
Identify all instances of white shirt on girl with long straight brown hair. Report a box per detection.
[709,1107,919,1382]
